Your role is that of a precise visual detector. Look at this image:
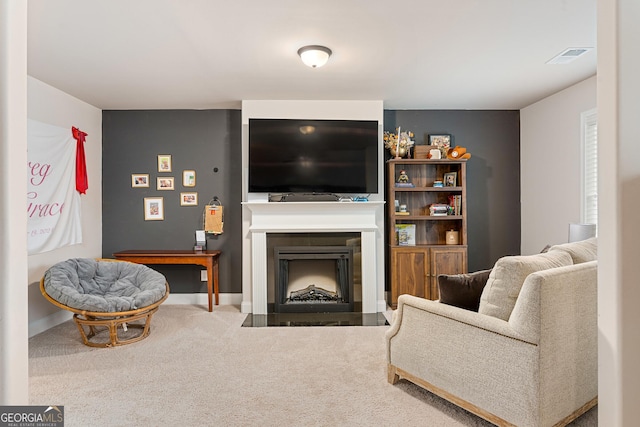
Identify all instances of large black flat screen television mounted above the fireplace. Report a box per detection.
[248,119,379,194]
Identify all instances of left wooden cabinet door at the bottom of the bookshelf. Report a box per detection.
[391,247,430,309]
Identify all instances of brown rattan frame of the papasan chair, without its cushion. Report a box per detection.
[40,259,169,348]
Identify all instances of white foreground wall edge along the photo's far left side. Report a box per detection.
[0,0,29,405]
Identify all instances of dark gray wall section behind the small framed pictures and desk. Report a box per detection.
[102,110,242,293]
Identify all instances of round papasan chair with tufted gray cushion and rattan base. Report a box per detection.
[40,258,169,347]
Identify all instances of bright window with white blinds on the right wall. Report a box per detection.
[580,109,598,229]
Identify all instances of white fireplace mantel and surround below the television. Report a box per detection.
[242,201,386,314]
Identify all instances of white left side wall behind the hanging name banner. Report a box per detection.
[27,77,102,336]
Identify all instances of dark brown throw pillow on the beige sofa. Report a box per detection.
[438,270,491,311]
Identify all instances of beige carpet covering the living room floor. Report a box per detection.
[29,305,597,427]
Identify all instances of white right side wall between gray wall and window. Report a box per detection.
[520,75,597,255]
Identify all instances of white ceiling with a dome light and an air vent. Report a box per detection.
[23,0,597,109]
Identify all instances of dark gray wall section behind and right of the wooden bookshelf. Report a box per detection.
[384,110,520,271]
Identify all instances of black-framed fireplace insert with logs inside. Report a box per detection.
[274,246,353,313]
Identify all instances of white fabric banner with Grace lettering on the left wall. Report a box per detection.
[27,120,82,255]
